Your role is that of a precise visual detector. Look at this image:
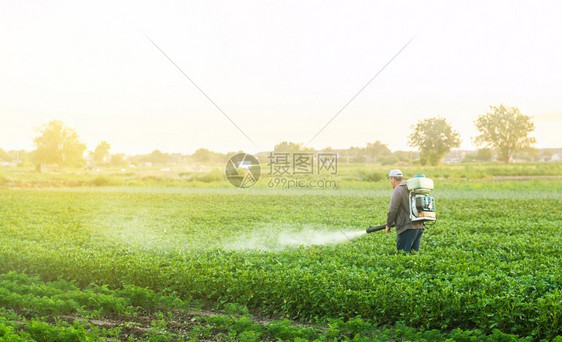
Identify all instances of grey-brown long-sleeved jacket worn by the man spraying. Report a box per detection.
[386,181,424,234]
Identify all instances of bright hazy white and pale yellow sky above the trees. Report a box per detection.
[0,0,562,153]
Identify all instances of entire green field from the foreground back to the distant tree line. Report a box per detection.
[0,164,562,341]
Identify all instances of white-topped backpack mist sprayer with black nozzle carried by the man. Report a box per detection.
[367,175,437,233]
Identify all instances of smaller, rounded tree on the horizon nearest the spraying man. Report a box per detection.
[408,116,461,165]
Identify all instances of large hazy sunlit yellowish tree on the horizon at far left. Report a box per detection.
[33,120,86,166]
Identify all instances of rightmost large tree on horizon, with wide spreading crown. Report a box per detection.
[474,105,536,164]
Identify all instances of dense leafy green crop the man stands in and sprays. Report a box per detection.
[0,183,562,339]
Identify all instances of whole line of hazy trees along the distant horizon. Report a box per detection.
[0,105,536,169]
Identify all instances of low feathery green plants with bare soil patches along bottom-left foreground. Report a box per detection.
[0,272,540,341]
